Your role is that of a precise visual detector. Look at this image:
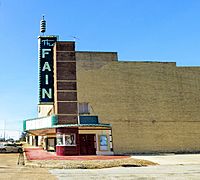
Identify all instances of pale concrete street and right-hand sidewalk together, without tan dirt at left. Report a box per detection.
[50,154,200,180]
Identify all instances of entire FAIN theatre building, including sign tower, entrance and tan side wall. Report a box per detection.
[24,25,200,155]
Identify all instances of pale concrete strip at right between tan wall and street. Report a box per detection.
[132,154,200,165]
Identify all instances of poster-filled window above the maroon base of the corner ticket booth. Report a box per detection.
[57,134,76,146]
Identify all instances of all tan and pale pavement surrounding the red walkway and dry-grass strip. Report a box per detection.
[0,153,200,180]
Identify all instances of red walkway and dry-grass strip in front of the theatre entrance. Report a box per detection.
[24,147,157,169]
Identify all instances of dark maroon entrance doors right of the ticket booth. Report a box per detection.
[79,134,96,155]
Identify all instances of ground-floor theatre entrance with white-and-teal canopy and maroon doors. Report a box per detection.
[24,115,113,156]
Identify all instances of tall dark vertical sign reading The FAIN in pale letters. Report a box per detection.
[38,36,57,104]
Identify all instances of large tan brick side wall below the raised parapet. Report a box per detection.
[76,57,200,153]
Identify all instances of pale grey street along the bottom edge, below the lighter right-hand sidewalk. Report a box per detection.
[50,165,200,180]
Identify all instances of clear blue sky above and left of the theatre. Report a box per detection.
[0,0,200,137]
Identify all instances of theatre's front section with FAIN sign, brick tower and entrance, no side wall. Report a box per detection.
[24,36,113,155]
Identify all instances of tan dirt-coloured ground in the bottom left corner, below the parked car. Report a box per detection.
[0,153,56,180]
